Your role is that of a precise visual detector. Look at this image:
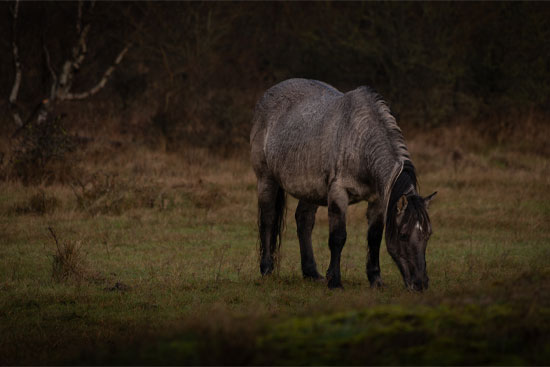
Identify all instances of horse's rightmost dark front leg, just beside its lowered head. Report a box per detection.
[367,202,384,288]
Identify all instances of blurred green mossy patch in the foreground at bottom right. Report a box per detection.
[258,305,549,365]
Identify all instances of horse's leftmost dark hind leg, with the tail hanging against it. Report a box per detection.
[258,179,284,275]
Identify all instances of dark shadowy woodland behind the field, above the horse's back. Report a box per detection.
[0,2,550,150]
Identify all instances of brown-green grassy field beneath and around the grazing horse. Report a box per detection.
[0,129,550,365]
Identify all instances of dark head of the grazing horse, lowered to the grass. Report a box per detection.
[386,192,437,291]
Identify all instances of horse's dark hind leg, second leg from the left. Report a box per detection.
[295,200,323,279]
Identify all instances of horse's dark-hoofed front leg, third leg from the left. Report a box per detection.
[327,187,348,288]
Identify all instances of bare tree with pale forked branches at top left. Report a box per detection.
[9,0,131,129]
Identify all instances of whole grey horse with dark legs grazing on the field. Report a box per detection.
[250,79,436,291]
